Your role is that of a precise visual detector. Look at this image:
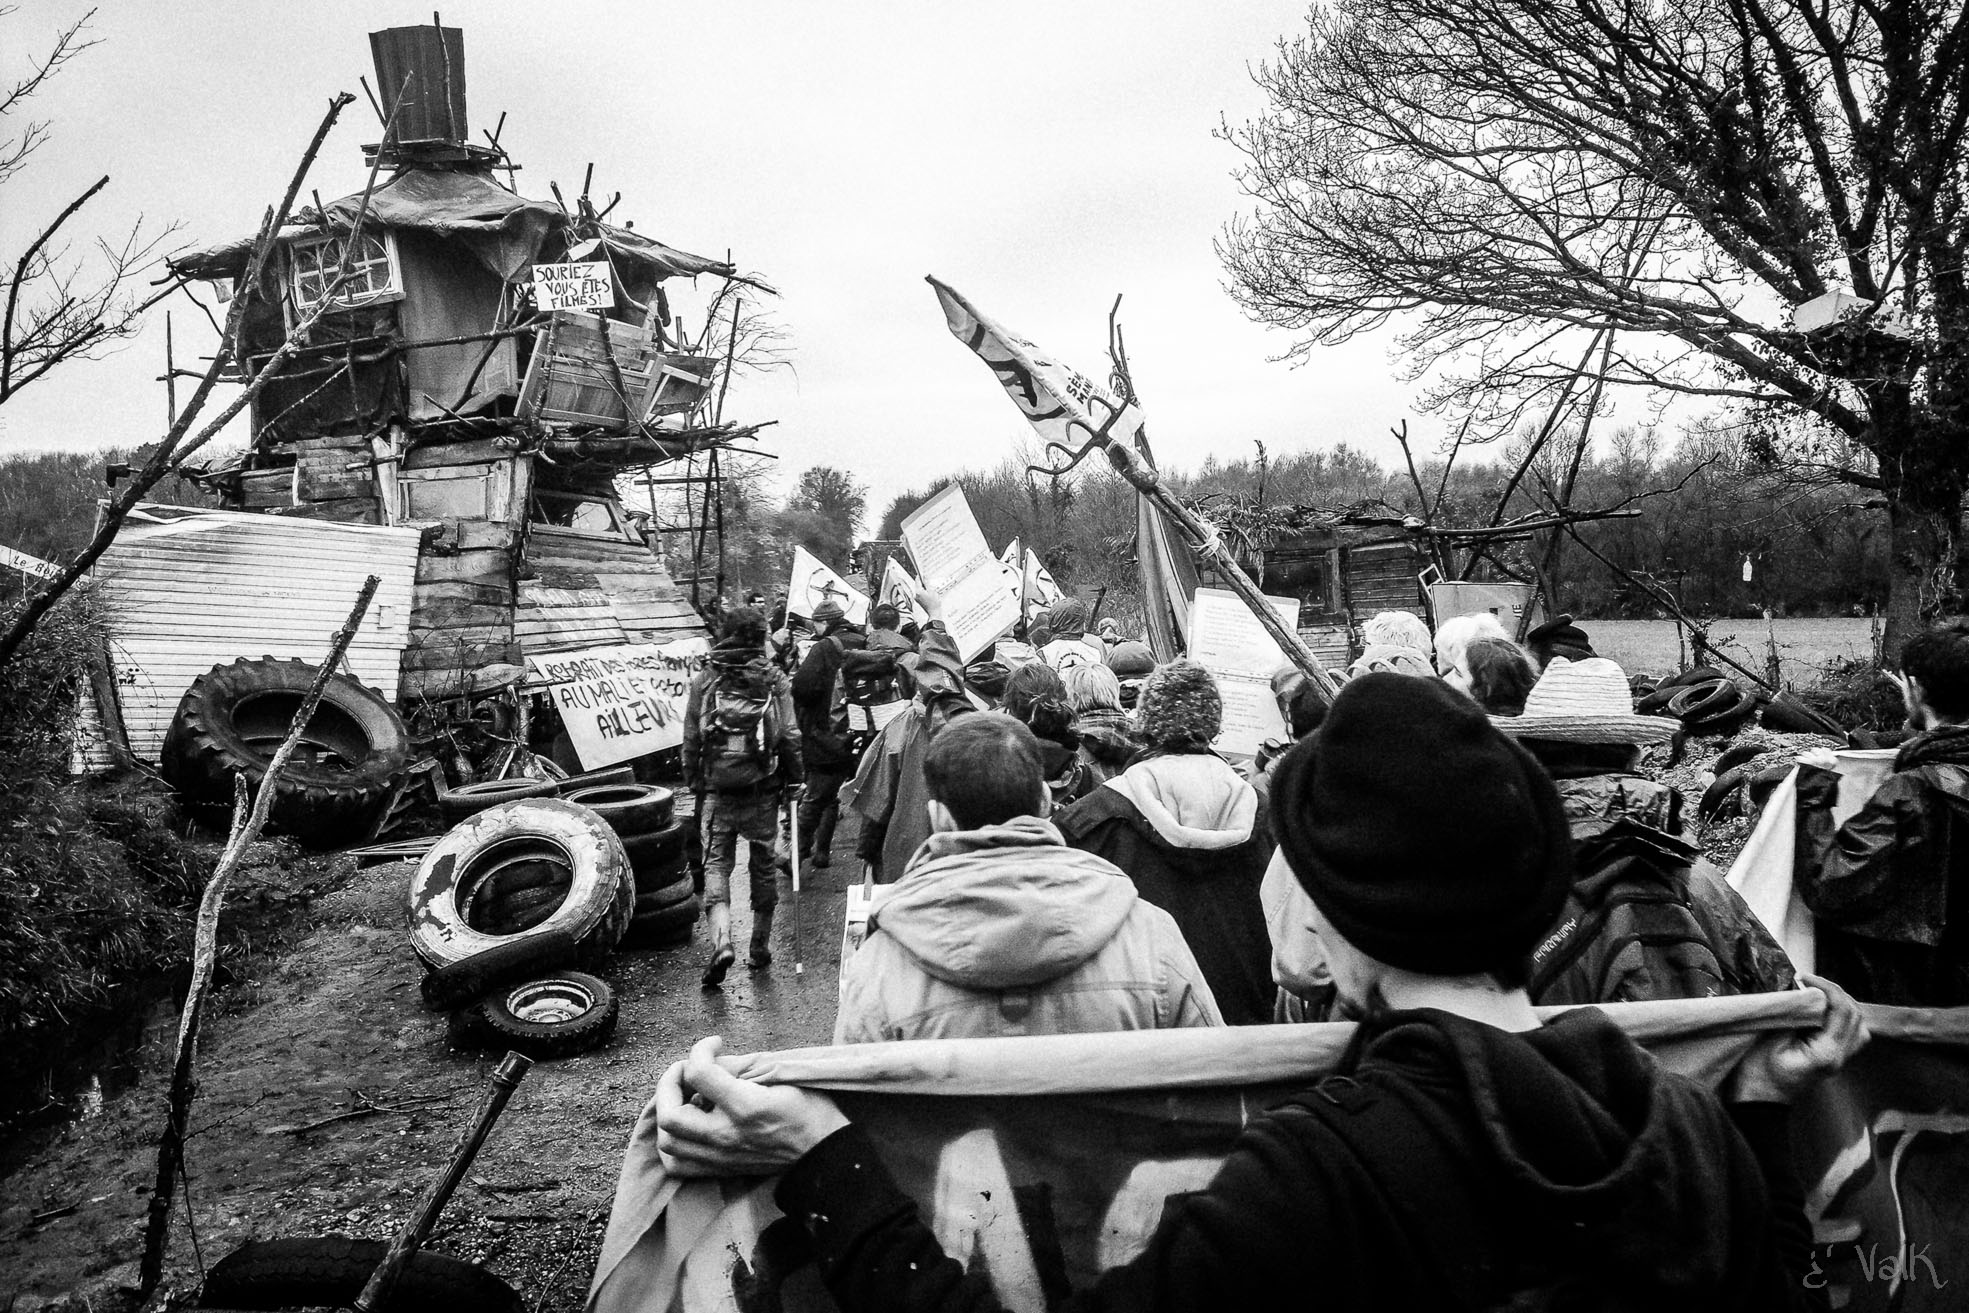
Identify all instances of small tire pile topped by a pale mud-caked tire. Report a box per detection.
[406,797,636,1059]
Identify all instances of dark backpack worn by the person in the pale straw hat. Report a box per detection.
[1530,817,1737,1006]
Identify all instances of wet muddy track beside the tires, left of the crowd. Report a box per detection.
[0,825,853,1311]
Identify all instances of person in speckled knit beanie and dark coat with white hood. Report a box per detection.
[1057,659,1276,1026]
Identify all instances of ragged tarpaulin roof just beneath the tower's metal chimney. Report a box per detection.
[171,169,732,289]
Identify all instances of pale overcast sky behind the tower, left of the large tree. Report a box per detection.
[0,0,1435,528]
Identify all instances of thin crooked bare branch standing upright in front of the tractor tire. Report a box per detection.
[138,575,382,1299]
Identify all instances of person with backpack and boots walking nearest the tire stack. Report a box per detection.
[683,606,803,988]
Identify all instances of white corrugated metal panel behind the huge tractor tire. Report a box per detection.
[95,506,419,762]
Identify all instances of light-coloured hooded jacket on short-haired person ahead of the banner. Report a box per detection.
[835,817,1221,1043]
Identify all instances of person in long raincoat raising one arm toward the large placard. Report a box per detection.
[841,593,977,884]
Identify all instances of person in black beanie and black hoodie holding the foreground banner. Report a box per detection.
[656,673,1865,1313]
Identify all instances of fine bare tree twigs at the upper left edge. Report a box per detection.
[0,6,177,404]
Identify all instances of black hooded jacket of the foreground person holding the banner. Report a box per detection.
[778,1008,1810,1313]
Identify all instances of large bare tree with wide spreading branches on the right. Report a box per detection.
[1221,0,1969,650]
